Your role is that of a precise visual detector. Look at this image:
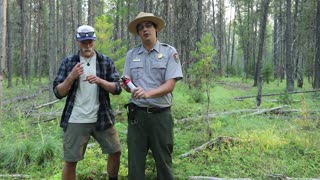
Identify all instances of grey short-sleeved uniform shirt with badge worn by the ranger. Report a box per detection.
[123,41,183,107]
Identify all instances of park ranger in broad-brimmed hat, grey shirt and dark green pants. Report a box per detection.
[121,12,183,180]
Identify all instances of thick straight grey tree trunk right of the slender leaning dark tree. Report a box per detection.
[286,0,294,92]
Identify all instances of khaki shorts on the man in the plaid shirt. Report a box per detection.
[63,123,121,162]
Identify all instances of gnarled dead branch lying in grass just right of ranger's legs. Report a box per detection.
[180,136,241,158]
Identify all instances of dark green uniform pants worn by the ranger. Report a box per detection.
[127,110,173,180]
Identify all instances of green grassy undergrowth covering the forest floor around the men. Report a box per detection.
[0,78,320,179]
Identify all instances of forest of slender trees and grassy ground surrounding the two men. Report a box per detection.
[0,0,320,179]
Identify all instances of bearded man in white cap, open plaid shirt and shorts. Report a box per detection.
[53,25,121,180]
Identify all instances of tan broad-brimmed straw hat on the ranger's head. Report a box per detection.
[128,12,165,35]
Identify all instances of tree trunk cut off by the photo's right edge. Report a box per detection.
[313,1,320,89]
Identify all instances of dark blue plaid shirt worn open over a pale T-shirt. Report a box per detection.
[53,51,122,130]
